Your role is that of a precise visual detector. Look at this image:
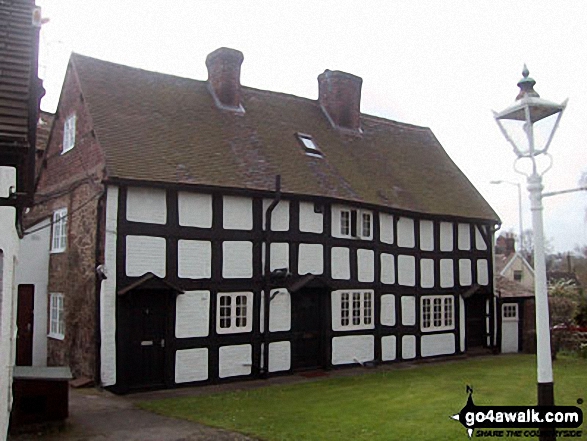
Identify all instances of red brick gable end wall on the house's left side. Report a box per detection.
[25,61,104,378]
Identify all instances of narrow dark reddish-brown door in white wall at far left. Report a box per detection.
[16,285,35,366]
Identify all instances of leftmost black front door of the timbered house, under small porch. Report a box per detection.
[129,290,169,388]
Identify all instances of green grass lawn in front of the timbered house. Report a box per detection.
[140,355,587,441]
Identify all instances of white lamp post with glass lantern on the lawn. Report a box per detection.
[493,65,567,440]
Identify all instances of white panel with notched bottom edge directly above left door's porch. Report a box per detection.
[126,236,167,278]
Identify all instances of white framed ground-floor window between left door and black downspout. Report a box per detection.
[216,292,253,334]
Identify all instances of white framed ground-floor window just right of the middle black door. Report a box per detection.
[332,290,374,330]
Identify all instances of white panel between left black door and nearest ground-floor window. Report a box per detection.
[175,291,210,338]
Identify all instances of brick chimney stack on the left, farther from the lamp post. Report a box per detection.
[206,47,244,111]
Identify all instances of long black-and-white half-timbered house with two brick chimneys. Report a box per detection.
[21,48,499,392]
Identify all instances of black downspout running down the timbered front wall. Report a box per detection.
[262,175,281,378]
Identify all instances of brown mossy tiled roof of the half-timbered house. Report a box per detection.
[72,54,498,221]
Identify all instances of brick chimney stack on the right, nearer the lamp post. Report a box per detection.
[318,70,363,131]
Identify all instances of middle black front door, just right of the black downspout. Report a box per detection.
[291,289,326,370]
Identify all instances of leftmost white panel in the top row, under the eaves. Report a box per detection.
[126,187,167,225]
